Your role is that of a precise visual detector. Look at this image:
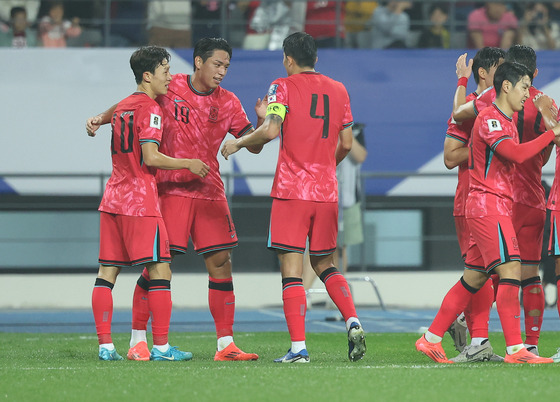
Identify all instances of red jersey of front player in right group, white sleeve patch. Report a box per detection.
[465,104,519,218]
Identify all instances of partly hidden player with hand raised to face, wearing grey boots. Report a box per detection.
[443,47,505,362]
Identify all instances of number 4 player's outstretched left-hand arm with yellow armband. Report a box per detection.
[221,103,286,160]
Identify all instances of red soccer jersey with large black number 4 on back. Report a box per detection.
[268,72,354,202]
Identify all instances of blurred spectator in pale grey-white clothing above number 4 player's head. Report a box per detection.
[243,0,307,50]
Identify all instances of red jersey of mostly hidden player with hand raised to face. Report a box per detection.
[445,92,478,216]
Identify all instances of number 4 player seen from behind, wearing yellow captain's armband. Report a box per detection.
[221,32,366,363]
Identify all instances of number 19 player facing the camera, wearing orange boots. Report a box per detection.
[86,38,266,360]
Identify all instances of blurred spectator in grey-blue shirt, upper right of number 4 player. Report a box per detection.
[370,1,412,49]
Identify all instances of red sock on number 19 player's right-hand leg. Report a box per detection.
[208,277,235,339]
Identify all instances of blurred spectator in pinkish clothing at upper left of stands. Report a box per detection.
[39,1,82,47]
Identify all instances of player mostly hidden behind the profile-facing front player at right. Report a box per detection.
[452,45,557,355]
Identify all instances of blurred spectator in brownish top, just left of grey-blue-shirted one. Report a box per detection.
[344,1,377,49]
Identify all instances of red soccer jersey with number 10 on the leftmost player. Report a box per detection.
[99,92,162,217]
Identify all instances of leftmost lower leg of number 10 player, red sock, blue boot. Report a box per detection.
[91,265,123,360]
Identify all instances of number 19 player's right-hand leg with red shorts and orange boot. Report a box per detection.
[189,199,258,361]
